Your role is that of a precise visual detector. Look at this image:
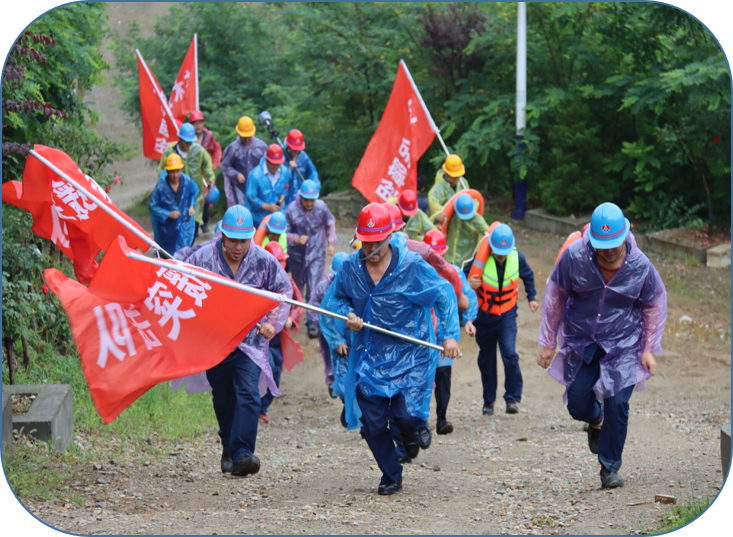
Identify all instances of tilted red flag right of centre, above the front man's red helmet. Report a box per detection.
[351,60,438,202]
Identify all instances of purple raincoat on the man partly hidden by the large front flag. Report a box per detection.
[171,241,293,396]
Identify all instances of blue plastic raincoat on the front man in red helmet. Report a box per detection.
[328,243,460,429]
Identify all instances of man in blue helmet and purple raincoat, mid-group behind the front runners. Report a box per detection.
[285,179,336,339]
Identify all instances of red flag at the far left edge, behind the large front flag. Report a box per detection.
[3,145,152,283]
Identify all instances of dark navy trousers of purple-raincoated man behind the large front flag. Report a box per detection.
[206,349,261,461]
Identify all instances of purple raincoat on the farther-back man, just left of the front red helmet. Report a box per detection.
[285,194,336,296]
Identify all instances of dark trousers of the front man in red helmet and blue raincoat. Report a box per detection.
[356,388,424,485]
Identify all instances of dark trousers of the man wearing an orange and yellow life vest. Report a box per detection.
[476,315,524,404]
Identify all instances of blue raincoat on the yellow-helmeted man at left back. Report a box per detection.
[148,170,199,254]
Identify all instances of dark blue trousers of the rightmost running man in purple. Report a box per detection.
[568,351,634,472]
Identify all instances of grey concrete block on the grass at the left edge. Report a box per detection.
[3,384,74,451]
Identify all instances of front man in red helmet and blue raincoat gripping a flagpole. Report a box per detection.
[325,203,460,495]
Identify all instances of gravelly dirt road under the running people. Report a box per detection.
[21,223,731,534]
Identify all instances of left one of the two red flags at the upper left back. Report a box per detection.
[135,50,178,162]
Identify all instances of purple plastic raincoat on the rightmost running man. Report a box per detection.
[538,231,667,401]
